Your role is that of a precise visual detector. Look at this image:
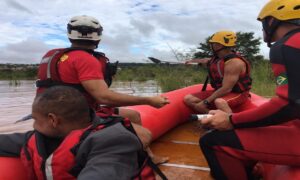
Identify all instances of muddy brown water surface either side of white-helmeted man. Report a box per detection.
[0,81,161,132]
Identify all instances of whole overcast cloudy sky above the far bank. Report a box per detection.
[0,0,268,64]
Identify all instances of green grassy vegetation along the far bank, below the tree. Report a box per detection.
[0,61,275,96]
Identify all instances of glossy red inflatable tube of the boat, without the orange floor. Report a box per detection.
[0,85,300,180]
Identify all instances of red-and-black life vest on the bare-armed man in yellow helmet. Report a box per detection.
[208,53,252,93]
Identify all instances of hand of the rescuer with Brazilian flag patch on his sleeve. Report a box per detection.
[201,110,233,131]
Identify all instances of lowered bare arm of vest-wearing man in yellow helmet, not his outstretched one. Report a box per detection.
[207,59,246,102]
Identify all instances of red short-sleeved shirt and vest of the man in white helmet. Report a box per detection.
[36,48,117,114]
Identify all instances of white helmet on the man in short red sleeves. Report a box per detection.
[68,15,103,41]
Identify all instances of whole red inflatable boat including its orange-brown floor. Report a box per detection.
[0,85,300,180]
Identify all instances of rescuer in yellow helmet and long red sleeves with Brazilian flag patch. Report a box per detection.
[200,0,300,180]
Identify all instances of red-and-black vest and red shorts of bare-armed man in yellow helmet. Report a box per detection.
[193,52,252,109]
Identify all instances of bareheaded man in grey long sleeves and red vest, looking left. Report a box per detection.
[0,86,142,180]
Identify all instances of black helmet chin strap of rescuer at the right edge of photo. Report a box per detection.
[262,17,281,47]
